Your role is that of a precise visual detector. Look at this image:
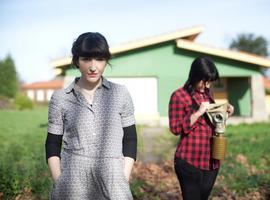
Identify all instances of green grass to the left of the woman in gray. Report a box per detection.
[0,108,50,199]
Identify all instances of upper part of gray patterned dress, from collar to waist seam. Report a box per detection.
[48,78,135,158]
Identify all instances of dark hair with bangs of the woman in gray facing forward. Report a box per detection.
[71,32,111,68]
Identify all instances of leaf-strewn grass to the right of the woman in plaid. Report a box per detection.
[220,123,270,193]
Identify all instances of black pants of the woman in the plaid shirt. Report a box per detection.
[174,158,218,200]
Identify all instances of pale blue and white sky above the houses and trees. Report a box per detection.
[0,0,270,83]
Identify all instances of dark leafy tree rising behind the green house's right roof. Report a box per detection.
[230,33,268,56]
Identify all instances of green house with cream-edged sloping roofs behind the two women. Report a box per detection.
[52,26,270,124]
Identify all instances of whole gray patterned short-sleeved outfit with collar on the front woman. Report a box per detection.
[48,77,135,200]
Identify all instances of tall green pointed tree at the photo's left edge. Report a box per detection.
[0,55,18,98]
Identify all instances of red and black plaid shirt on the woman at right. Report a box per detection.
[169,88,220,170]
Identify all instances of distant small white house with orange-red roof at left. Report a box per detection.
[22,79,64,103]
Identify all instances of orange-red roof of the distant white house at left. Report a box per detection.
[22,79,64,89]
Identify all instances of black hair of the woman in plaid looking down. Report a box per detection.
[184,57,219,93]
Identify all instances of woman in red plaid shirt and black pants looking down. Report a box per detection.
[169,58,234,200]
